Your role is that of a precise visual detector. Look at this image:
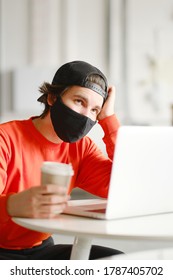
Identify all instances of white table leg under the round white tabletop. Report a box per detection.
[70,236,92,260]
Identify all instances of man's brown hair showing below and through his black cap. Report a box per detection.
[37,74,106,118]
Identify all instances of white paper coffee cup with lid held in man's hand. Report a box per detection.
[41,161,74,189]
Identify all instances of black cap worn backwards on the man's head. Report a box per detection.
[52,61,108,100]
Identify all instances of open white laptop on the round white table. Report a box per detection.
[64,126,173,219]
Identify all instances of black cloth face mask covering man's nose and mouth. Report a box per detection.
[50,97,96,143]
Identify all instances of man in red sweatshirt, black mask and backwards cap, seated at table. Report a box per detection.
[0,61,120,259]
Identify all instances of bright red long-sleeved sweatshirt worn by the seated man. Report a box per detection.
[0,115,119,250]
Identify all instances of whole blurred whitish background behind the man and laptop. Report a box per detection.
[0,0,173,125]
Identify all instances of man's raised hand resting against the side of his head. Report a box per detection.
[97,86,115,121]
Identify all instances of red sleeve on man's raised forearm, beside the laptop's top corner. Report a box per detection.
[99,115,120,160]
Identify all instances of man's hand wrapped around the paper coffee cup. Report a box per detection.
[7,185,69,218]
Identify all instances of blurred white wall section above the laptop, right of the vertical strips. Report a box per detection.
[127,0,173,125]
